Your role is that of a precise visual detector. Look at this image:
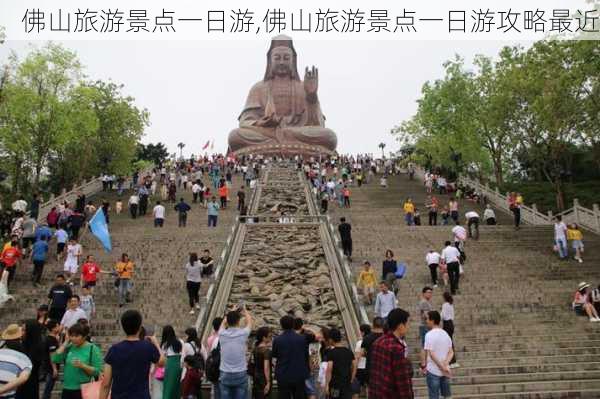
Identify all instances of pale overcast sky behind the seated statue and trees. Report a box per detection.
[0,40,528,155]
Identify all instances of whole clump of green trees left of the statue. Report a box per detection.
[0,44,149,198]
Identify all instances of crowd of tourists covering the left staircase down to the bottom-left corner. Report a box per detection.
[0,152,270,399]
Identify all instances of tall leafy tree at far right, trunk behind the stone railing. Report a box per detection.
[513,41,585,210]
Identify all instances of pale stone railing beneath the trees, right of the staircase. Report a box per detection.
[415,168,600,234]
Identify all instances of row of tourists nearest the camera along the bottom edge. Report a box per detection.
[0,304,454,399]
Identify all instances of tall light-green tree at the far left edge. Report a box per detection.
[0,43,81,190]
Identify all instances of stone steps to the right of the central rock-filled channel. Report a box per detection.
[329,175,600,398]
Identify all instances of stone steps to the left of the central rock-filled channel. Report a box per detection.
[0,175,241,397]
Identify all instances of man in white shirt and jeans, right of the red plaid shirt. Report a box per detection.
[421,310,454,398]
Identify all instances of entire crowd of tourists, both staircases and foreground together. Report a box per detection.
[0,155,600,399]
